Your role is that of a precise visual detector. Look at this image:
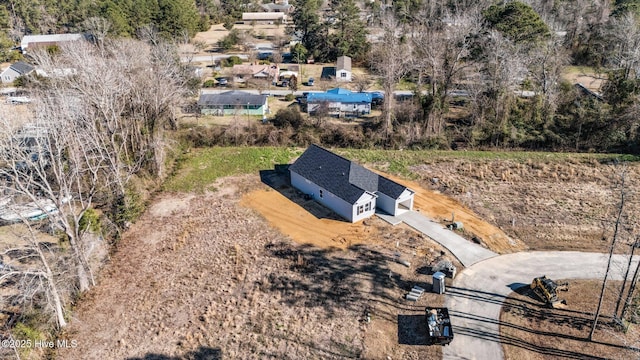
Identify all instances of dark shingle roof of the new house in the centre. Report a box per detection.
[289,145,406,204]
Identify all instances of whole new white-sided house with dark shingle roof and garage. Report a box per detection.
[289,145,414,222]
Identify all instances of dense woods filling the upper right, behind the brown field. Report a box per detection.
[282,0,640,153]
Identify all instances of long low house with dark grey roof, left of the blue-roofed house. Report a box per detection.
[198,90,269,118]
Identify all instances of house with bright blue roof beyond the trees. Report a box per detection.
[307,88,372,117]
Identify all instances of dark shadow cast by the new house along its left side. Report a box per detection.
[260,164,345,222]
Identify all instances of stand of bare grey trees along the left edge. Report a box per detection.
[0,35,193,328]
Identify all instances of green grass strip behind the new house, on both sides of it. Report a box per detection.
[164,147,640,192]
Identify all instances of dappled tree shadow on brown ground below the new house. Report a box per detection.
[257,243,428,321]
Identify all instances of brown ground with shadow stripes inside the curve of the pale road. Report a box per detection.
[500,280,640,360]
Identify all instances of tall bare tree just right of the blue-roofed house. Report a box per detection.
[371,14,411,138]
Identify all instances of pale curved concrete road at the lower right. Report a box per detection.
[443,251,637,360]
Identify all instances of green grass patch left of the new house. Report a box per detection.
[164,147,302,192]
